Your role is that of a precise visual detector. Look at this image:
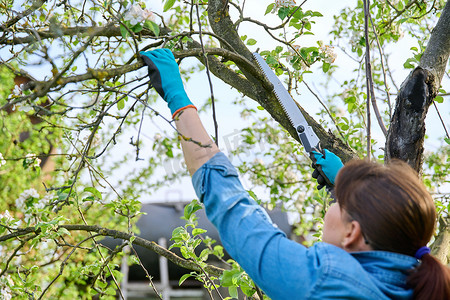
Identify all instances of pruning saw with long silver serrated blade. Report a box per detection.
[253,52,333,187]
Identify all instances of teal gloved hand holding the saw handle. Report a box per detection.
[310,149,344,190]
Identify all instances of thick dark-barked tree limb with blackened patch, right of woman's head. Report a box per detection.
[385,1,450,173]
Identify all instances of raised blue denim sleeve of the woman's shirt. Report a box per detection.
[192,153,319,299]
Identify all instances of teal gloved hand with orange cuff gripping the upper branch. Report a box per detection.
[139,49,196,118]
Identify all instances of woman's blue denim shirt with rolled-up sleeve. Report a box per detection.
[192,153,418,300]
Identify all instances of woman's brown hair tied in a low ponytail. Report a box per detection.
[335,160,450,300]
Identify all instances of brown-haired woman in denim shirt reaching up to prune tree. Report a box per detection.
[141,49,450,299]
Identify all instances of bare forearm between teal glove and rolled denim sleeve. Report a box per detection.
[175,108,220,176]
